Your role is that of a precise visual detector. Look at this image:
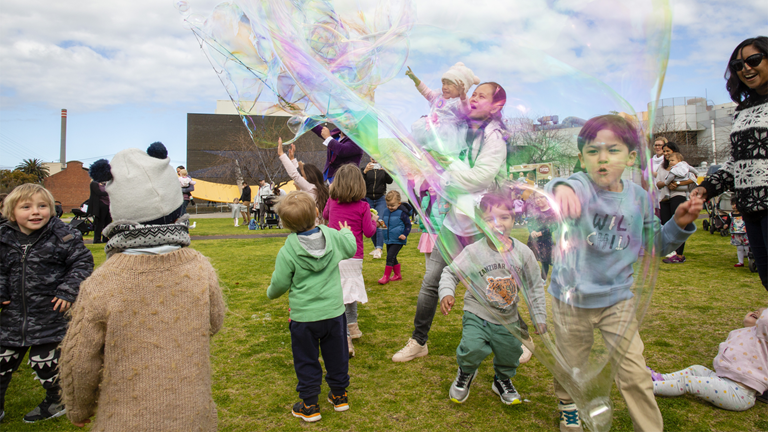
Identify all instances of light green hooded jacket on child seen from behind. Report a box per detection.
[267,225,357,322]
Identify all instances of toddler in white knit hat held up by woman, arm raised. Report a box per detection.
[405,62,480,167]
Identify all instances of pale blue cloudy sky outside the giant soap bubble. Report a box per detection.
[0,0,768,169]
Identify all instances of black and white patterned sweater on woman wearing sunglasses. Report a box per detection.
[701,98,768,214]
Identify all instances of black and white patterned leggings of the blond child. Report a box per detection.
[0,342,61,404]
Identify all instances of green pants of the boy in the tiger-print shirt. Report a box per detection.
[456,311,523,380]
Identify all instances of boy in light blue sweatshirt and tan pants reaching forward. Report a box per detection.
[547,115,702,431]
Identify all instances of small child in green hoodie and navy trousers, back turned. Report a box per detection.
[267,191,360,422]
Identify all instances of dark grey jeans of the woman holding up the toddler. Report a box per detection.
[411,227,483,345]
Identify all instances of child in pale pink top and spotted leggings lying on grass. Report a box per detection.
[651,308,768,411]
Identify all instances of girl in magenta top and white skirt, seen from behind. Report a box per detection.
[323,164,379,357]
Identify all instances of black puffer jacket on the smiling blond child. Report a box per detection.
[0,217,93,347]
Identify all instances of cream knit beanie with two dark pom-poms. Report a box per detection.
[89,142,184,223]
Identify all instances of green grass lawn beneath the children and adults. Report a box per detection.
[1,224,768,431]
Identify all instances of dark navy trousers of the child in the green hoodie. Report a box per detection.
[289,314,349,405]
